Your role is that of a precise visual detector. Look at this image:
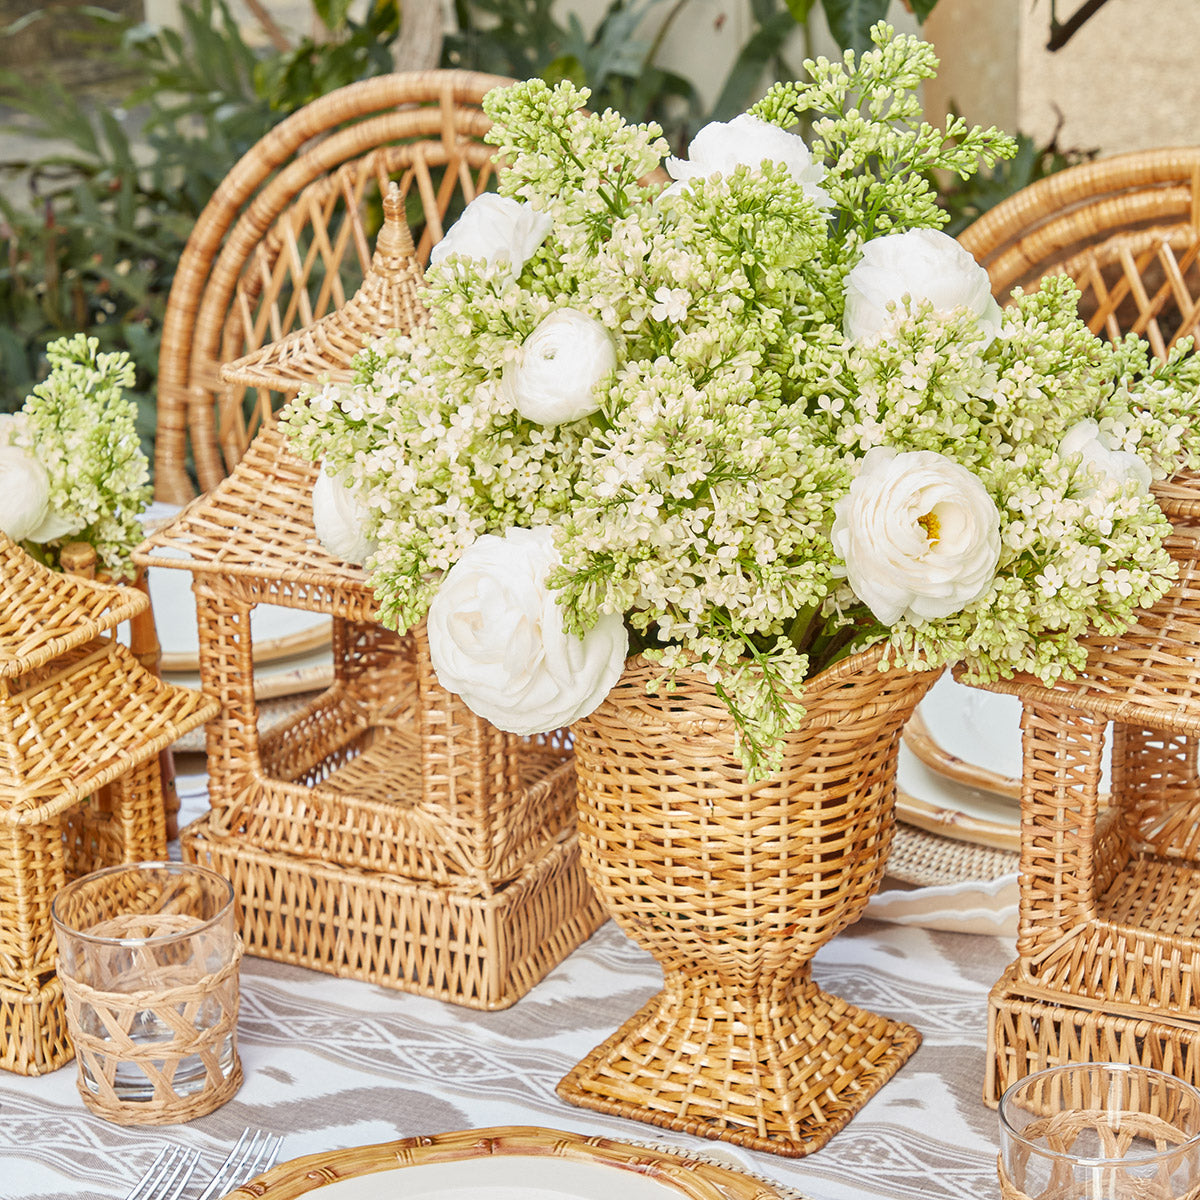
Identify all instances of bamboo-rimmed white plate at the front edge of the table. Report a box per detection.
[226,1126,781,1200]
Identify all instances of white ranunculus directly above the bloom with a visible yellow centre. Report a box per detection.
[844,229,1002,342]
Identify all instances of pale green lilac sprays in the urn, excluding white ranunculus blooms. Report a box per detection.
[282,25,1200,778]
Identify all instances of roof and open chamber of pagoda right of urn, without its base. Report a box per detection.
[964,538,1200,1016]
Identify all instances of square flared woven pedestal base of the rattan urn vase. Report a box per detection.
[558,976,920,1158]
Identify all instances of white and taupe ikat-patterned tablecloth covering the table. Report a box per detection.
[0,755,1015,1200]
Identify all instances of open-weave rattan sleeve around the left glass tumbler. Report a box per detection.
[62,917,242,1126]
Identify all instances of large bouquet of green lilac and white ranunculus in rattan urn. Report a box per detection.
[284,24,1200,778]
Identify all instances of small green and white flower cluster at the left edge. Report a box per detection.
[0,334,150,577]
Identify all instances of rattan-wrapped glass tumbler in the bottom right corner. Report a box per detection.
[1000,1062,1200,1200]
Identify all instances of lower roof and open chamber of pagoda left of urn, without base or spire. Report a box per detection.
[138,428,575,894]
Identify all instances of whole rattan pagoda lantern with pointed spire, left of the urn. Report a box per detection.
[134,185,605,1008]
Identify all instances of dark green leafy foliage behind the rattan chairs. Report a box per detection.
[0,0,1089,477]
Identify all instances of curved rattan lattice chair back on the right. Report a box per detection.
[959,146,1200,355]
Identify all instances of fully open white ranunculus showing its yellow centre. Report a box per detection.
[830,446,1000,625]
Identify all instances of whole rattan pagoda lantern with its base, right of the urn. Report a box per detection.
[984,492,1200,1104]
